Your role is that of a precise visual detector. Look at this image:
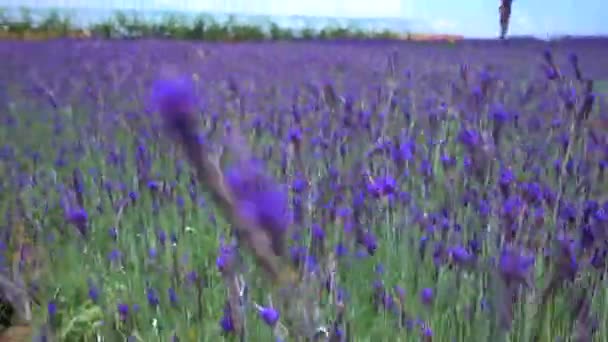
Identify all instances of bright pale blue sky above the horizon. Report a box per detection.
[0,0,608,38]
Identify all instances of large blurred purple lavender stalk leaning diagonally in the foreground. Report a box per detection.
[152,78,291,280]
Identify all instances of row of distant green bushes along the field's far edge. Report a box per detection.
[0,8,409,41]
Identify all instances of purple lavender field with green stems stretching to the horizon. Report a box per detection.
[0,39,608,342]
